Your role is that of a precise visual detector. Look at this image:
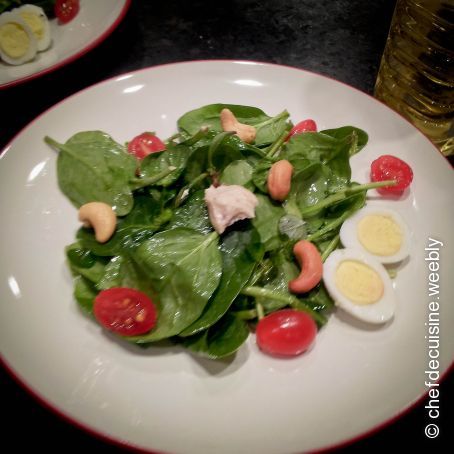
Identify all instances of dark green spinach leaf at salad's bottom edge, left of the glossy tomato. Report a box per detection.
[179,313,249,359]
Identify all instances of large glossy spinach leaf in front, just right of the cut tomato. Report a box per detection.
[133,228,222,343]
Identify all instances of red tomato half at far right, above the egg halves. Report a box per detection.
[370,155,413,195]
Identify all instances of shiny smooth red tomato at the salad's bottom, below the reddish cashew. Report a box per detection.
[256,309,317,356]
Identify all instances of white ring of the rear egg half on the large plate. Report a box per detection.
[339,206,410,264]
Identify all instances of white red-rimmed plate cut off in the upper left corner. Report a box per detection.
[0,0,131,89]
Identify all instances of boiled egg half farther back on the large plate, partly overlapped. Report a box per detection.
[340,206,410,264]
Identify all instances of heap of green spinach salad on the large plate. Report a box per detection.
[45,104,389,359]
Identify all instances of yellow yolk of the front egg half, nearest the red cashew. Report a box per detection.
[335,260,384,305]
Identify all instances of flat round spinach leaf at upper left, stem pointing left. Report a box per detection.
[45,131,137,216]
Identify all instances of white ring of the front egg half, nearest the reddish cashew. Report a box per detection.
[323,249,396,324]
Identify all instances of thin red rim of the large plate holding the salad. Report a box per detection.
[0,60,454,454]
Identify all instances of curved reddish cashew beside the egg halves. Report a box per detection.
[288,240,323,293]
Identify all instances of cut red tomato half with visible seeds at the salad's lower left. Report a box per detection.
[93,287,156,336]
